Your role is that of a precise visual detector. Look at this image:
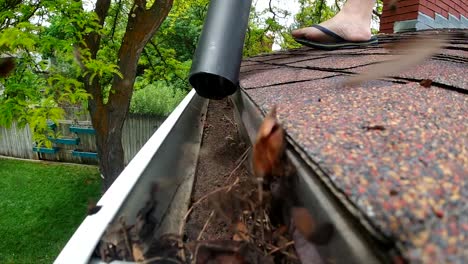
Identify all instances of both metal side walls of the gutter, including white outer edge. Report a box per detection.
[55,86,395,264]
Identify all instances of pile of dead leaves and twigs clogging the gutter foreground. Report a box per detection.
[96,104,333,264]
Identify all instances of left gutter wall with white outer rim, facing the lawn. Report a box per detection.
[54,90,208,264]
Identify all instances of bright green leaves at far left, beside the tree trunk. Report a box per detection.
[0,1,89,147]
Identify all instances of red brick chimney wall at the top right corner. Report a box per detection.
[380,0,468,33]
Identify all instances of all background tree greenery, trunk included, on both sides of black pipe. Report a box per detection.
[0,0,381,189]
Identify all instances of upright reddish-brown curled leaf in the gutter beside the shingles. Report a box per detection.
[252,107,286,178]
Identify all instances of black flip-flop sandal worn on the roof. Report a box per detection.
[294,25,378,50]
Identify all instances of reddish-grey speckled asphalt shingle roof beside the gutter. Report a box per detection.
[240,31,468,263]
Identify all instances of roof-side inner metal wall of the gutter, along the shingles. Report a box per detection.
[231,90,398,264]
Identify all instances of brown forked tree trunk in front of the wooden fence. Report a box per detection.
[84,0,173,192]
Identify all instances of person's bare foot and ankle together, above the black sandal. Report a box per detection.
[291,0,375,42]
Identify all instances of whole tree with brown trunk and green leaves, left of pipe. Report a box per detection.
[0,0,176,189]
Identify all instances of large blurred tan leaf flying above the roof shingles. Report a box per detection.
[344,35,447,85]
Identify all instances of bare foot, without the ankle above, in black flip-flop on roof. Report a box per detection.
[291,12,371,43]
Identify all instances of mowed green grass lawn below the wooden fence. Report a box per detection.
[0,158,100,263]
